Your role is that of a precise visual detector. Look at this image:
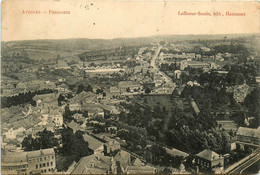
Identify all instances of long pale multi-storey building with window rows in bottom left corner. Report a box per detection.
[1,148,56,174]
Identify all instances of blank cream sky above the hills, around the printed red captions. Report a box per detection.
[2,0,260,41]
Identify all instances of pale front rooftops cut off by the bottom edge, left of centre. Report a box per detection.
[66,150,156,174]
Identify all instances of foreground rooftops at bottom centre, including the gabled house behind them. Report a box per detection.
[58,127,156,174]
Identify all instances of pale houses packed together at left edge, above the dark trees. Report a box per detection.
[1,93,64,151]
